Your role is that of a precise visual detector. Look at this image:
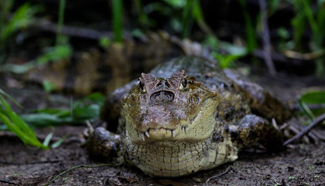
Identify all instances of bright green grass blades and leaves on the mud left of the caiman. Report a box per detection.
[0,89,105,149]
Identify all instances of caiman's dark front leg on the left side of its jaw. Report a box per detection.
[86,127,121,161]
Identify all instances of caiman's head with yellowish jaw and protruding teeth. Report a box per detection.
[122,70,218,143]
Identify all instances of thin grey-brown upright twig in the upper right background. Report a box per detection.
[259,0,276,75]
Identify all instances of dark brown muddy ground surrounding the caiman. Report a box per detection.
[0,69,325,186]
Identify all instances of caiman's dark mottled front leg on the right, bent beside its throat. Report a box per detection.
[229,114,283,151]
